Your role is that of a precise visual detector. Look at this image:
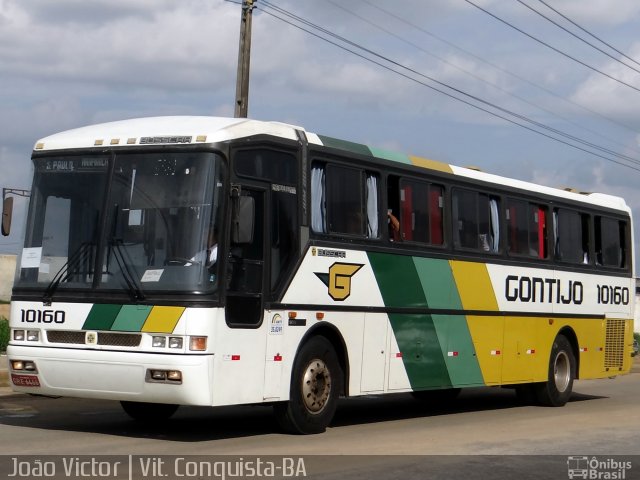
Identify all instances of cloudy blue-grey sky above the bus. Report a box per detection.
[0,0,640,272]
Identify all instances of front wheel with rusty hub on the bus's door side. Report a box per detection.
[273,336,342,434]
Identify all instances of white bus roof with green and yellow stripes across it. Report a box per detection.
[34,116,631,213]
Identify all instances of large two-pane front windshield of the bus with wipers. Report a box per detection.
[16,151,222,300]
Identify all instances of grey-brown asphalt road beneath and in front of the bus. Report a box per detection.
[0,362,640,479]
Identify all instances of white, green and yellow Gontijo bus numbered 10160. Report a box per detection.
[3,117,635,433]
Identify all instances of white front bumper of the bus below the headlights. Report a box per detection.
[7,345,213,405]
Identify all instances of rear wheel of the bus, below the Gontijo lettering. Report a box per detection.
[535,335,576,407]
